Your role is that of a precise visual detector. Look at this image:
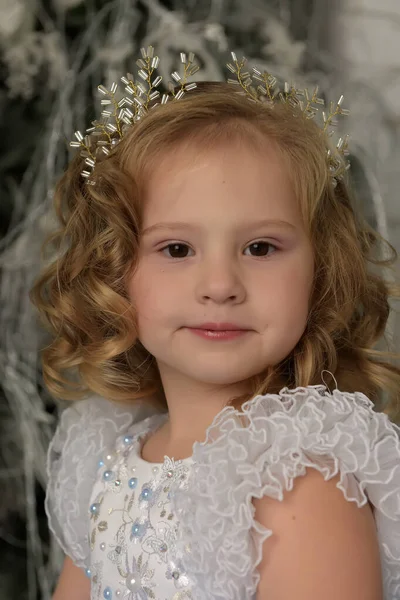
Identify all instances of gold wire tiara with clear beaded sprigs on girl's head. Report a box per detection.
[70,46,350,186]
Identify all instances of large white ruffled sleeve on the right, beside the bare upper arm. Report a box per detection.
[173,386,400,600]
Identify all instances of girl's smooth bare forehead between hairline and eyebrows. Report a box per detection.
[144,145,299,227]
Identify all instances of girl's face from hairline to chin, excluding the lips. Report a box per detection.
[129,141,314,394]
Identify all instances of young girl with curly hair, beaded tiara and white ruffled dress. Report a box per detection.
[32,49,400,600]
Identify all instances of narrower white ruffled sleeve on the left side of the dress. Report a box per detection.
[45,396,161,568]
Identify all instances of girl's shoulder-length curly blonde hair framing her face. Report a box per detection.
[31,83,400,421]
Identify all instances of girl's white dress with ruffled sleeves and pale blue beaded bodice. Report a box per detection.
[46,385,400,600]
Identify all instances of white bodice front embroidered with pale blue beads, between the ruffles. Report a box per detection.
[87,417,193,600]
